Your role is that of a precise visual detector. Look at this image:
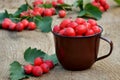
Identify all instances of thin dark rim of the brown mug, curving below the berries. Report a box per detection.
[52,25,103,38]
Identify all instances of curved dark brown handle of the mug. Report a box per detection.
[96,37,113,61]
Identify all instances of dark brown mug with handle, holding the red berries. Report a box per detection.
[53,27,113,71]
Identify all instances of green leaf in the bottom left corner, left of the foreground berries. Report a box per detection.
[10,61,28,80]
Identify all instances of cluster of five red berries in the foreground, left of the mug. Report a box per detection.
[24,57,54,77]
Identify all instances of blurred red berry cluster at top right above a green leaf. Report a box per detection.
[92,0,109,12]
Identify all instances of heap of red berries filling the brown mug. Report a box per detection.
[53,18,101,36]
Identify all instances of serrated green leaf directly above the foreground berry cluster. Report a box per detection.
[24,47,45,64]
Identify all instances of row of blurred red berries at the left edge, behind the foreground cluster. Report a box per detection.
[2,18,36,31]
